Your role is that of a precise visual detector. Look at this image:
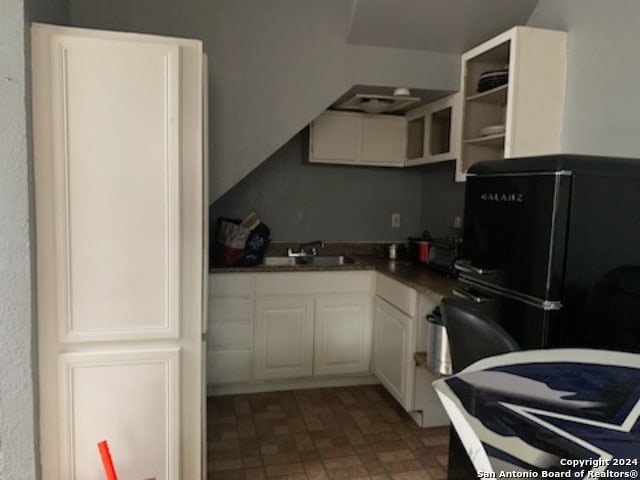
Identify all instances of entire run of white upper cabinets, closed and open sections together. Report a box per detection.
[309,27,567,177]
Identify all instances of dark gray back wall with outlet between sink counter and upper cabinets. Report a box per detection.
[211,129,422,242]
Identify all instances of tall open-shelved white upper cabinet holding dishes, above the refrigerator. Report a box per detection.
[456,27,567,180]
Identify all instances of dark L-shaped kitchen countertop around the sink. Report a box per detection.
[209,244,456,297]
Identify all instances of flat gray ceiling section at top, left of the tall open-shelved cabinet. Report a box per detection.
[347,0,538,53]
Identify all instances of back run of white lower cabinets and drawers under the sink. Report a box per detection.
[212,271,375,391]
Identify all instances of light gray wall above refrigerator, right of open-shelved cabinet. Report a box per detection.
[529,0,640,158]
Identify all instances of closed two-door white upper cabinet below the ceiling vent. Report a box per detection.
[309,111,406,167]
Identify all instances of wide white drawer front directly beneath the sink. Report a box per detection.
[256,271,373,295]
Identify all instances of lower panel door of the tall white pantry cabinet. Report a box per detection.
[59,348,180,479]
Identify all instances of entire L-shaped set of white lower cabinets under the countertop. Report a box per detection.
[207,271,447,427]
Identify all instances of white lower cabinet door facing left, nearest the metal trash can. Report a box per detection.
[373,297,413,410]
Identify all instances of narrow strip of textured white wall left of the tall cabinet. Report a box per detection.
[0,0,37,479]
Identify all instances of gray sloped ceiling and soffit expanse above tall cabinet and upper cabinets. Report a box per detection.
[69,0,537,201]
